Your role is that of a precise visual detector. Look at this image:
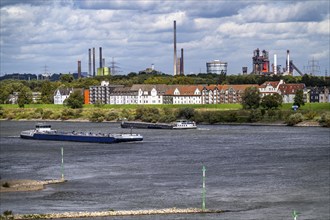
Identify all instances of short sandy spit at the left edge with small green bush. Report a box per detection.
[0,179,66,193]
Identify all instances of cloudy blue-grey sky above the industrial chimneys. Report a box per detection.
[0,0,330,75]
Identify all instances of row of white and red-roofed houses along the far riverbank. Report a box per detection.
[54,80,330,105]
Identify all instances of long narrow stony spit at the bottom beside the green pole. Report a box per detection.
[9,208,225,220]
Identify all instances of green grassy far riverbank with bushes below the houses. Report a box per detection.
[0,103,330,127]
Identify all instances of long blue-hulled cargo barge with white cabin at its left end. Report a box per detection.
[20,124,143,144]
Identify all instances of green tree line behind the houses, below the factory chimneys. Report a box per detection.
[0,71,330,105]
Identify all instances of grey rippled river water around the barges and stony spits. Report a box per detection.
[0,121,330,220]
